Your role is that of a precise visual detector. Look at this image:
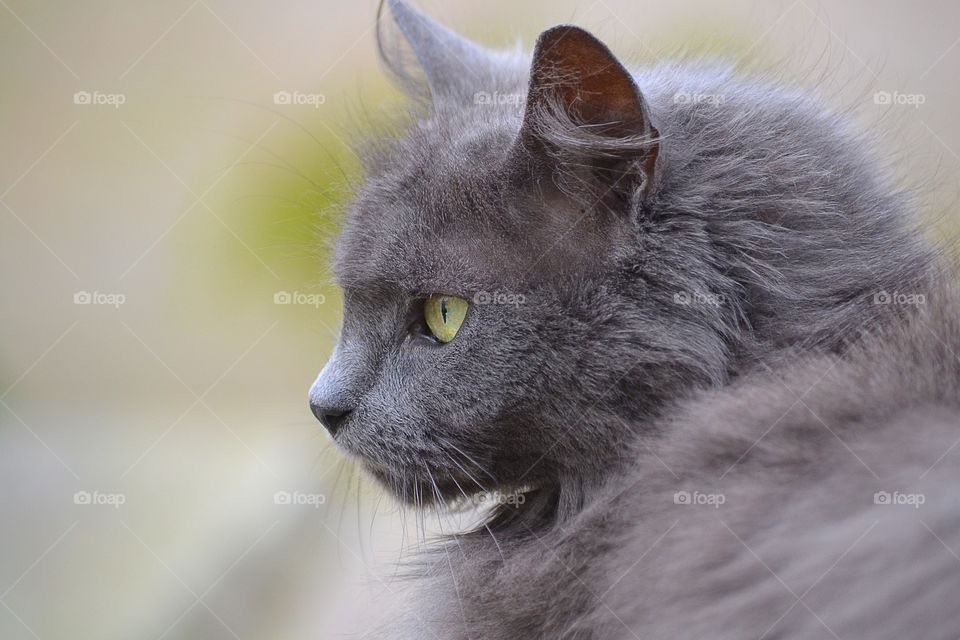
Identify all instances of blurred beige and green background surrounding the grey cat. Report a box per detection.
[0,0,960,640]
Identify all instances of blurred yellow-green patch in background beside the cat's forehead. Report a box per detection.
[177,79,406,336]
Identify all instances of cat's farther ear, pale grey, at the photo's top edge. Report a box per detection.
[377,0,510,102]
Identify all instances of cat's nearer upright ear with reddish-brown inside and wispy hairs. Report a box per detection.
[515,25,660,209]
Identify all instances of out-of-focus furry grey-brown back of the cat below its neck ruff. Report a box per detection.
[585,282,960,638]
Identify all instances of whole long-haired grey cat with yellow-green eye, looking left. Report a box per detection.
[310,0,960,640]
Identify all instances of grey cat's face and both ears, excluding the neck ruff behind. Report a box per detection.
[310,2,725,510]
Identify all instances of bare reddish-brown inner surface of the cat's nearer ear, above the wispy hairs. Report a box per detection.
[530,26,648,134]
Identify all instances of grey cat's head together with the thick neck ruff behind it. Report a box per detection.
[310,0,922,510]
